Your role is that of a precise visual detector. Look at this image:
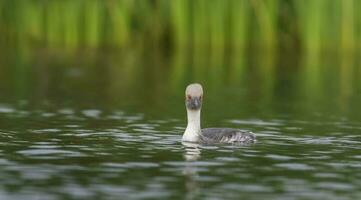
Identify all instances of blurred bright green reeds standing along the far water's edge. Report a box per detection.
[0,0,361,57]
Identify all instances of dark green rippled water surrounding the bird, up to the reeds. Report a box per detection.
[0,54,361,199]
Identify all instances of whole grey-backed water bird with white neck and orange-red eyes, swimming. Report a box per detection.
[182,83,256,143]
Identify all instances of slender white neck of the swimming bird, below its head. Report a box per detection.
[182,109,201,142]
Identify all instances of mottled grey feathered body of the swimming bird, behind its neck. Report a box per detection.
[200,128,256,143]
